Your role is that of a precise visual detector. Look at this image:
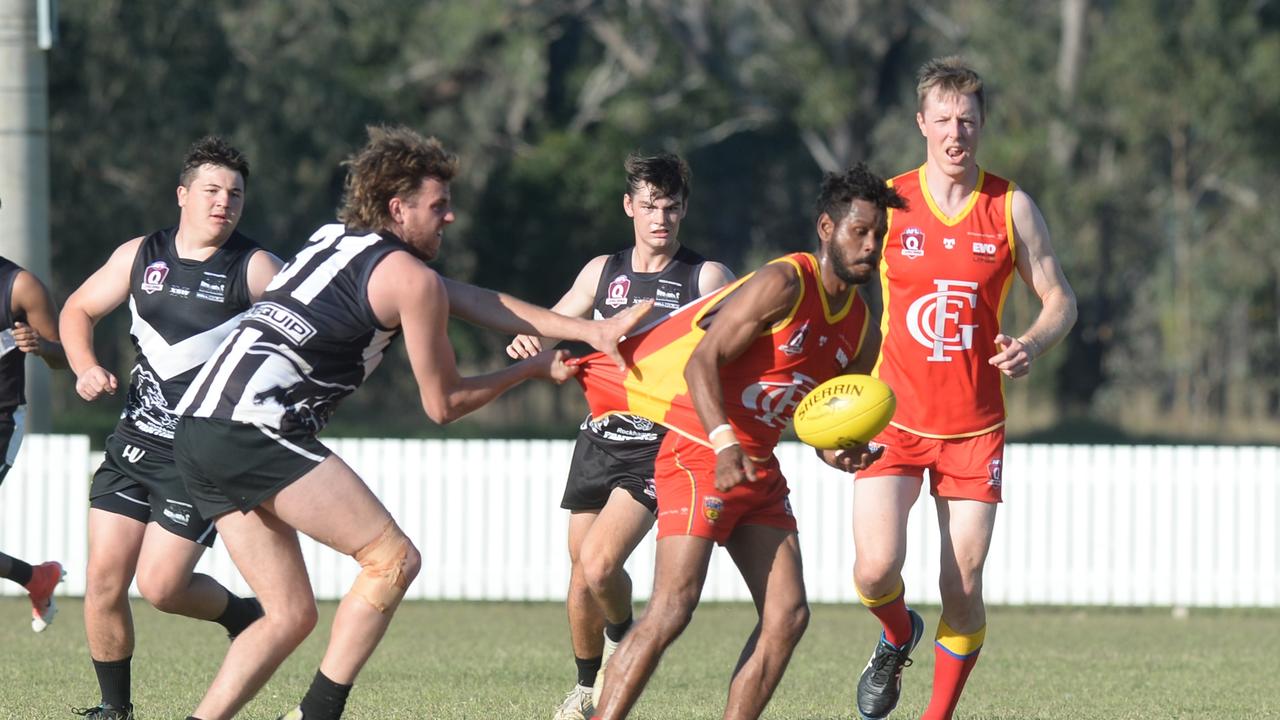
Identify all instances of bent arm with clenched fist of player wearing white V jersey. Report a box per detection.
[58,237,142,400]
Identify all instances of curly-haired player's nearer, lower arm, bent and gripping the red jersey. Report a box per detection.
[369,252,577,425]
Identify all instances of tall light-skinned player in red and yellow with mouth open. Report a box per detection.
[854,58,1075,720]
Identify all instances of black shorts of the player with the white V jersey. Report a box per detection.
[88,434,216,547]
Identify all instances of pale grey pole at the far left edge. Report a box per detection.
[0,0,59,432]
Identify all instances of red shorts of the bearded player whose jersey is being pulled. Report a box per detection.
[654,433,796,544]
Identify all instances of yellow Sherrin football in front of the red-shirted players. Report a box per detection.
[795,375,897,450]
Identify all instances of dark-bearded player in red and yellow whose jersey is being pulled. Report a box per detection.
[577,165,902,720]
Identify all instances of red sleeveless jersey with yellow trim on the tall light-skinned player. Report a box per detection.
[873,167,1016,438]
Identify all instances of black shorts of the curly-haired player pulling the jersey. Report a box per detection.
[173,418,333,518]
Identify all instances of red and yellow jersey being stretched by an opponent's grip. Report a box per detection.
[577,252,867,459]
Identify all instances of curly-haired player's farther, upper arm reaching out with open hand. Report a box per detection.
[440,271,653,368]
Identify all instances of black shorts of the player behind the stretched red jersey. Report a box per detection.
[561,433,659,516]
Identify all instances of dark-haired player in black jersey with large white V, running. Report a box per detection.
[61,137,280,720]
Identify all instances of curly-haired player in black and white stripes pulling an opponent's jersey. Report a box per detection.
[167,128,649,720]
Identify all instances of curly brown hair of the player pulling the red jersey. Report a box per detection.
[338,126,458,231]
